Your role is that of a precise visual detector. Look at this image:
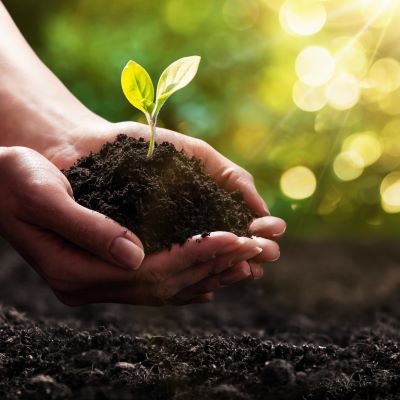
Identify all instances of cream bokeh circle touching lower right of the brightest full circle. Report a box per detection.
[326,73,360,110]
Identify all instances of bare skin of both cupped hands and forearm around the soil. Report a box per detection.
[0,2,286,305]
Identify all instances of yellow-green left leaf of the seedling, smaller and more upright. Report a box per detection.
[121,60,154,114]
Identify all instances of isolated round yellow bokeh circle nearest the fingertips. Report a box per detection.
[280,165,317,200]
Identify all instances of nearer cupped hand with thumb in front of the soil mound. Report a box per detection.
[0,147,276,305]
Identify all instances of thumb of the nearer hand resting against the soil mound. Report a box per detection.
[36,194,144,269]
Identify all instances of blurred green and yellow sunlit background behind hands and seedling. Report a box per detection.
[4,0,400,238]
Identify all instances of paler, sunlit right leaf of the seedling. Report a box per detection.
[153,56,201,118]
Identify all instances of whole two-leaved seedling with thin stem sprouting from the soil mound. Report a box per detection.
[121,56,200,159]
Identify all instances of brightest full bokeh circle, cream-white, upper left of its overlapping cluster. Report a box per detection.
[296,46,335,86]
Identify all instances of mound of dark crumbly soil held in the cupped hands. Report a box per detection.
[63,135,255,253]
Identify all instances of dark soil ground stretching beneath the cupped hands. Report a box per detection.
[0,240,400,400]
